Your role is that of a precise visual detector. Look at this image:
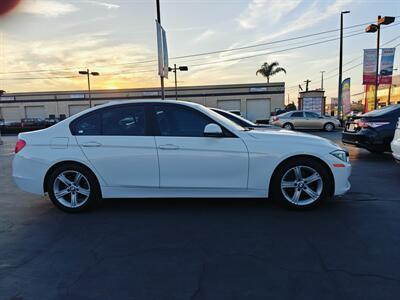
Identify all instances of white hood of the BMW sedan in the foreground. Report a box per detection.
[248,129,342,150]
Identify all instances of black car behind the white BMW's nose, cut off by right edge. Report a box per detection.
[342,104,400,153]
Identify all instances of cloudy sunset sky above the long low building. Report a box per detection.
[0,0,400,100]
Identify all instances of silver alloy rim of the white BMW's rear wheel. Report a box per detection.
[53,170,90,208]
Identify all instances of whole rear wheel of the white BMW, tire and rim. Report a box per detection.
[47,164,101,212]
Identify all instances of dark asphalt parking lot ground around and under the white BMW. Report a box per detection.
[0,132,400,300]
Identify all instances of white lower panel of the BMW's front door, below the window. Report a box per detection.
[156,136,249,189]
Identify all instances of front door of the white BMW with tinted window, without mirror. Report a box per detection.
[153,103,249,189]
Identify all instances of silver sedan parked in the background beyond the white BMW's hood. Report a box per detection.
[269,110,341,131]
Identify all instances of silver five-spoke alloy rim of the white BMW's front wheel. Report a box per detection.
[281,166,323,206]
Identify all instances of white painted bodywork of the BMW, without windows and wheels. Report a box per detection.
[13,100,351,198]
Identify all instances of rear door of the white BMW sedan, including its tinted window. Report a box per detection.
[72,104,159,188]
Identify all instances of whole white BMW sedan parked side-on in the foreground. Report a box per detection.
[13,100,351,212]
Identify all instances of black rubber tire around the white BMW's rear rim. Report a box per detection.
[46,163,101,213]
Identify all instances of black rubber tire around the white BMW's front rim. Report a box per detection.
[270,157,333,210]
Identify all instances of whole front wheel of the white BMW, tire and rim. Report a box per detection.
[271,157,332,210]
